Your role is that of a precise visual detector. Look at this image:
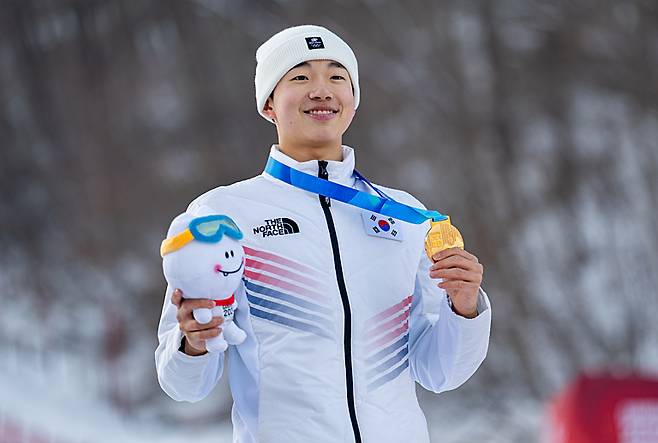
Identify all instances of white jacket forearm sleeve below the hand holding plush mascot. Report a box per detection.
[155,287,224,402]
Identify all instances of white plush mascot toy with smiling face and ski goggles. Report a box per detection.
[160,208,246,352]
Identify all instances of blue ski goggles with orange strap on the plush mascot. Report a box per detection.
[160,215,242,257]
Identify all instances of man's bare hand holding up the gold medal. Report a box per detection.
[430,248,484,318]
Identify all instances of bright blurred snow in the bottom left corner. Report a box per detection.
[0,362,231,443]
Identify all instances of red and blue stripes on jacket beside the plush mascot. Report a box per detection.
[243,246,333,339]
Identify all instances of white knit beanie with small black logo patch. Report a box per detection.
[255,25,360,122]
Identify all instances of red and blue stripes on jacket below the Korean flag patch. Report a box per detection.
[363,295,412,391]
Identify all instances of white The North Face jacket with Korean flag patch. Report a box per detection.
[155,146,491,443]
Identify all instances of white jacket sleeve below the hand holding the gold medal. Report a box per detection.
[409,252,491,392]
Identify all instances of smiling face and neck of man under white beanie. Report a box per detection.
[263,60,355,160]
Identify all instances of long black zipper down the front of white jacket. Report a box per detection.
[318,160,361,443]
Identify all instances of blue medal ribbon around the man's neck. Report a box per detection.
[265,157,448,225]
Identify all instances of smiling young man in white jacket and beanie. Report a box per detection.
[156,26,491,443]
